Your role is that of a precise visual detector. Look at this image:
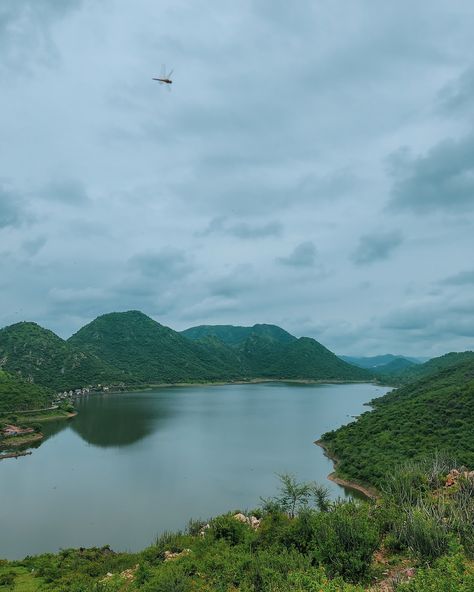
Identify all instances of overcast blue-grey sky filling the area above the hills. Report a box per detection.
[0,0,474,357]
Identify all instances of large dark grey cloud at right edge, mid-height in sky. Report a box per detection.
[391,134,474,214]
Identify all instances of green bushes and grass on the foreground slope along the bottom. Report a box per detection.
[0,458,474,592]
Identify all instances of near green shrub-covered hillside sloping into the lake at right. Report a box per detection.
[321,352,474,486]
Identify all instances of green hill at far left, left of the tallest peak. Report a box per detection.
[0,322,128,390]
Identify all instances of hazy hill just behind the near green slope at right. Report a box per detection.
[374,351,474,385]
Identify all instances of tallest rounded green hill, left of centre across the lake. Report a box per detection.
[68,310,244,384]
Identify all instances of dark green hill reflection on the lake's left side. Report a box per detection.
[70,393,170,448]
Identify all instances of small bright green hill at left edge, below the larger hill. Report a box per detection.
[0,370,53,413]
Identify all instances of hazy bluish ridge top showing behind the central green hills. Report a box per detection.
[181,324,296,345]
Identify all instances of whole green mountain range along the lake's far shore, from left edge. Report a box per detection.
[0,311,374,408]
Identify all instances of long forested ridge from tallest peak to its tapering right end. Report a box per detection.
[69,311,372,383]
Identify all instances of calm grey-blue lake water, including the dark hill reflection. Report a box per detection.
[0,383,388,559]
